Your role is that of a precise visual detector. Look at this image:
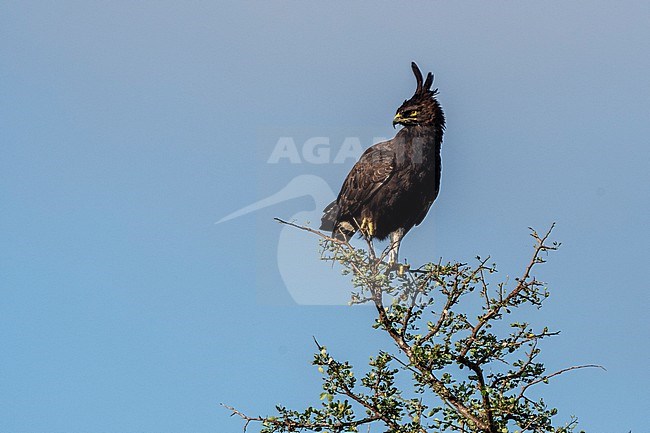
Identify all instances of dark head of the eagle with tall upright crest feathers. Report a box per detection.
[393,62,445,128]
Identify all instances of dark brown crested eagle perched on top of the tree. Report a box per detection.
[320,62,445,266]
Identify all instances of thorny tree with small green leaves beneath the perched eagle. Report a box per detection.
[226,221,597,433]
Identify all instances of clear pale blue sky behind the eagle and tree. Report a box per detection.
[0,1,650,433]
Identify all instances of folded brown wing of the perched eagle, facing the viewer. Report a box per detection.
[336,141,395,222]
